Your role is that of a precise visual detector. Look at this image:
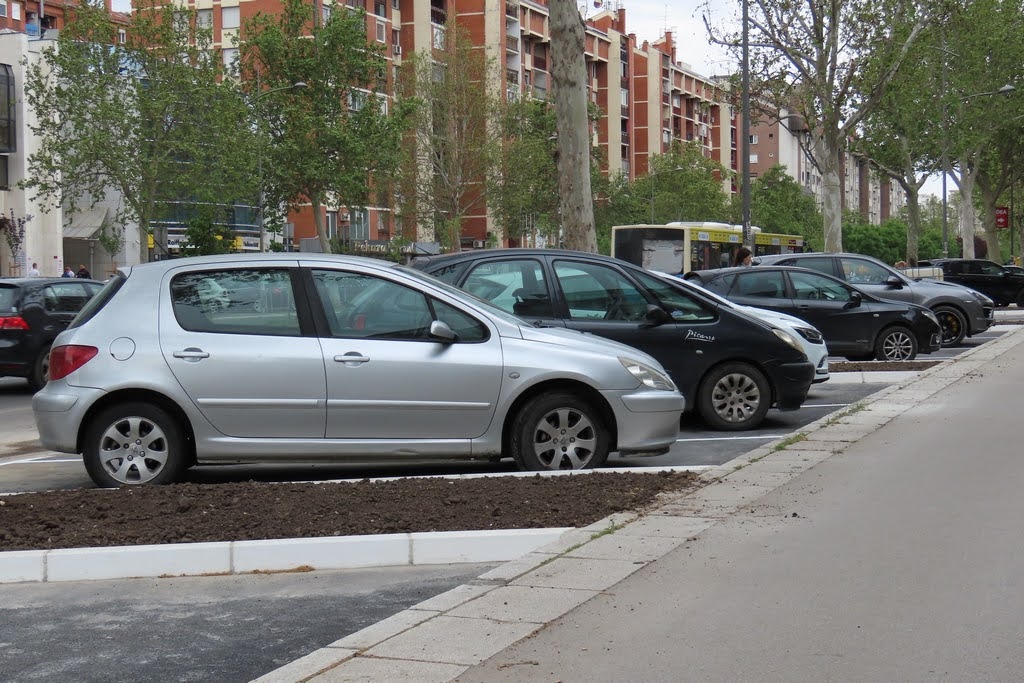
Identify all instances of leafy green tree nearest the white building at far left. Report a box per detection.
[22,0,252,261]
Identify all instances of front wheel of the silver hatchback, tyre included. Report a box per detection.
[510,392,611,470]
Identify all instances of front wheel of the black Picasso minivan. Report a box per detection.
[697,362,771,431]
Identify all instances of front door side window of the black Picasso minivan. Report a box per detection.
[555,261,647,321]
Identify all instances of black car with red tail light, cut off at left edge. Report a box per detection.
[0,278,103,391]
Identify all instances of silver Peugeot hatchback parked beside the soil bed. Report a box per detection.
[33,254,684,486]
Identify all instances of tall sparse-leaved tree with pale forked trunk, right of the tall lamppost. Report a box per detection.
[708,0,932,252]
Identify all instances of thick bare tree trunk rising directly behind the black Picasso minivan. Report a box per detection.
[550,0,597,252]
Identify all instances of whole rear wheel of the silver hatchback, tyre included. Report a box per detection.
[82,403,186,487]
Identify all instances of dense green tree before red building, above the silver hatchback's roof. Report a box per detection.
[239,0,415,253]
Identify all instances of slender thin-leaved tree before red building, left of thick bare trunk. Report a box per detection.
[399,18,504,251]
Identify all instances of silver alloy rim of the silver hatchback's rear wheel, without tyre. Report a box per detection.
[99,416,168,484]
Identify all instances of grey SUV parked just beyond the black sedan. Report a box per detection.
[754,252,995,346]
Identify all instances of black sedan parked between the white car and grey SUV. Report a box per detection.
[685,265,941,360]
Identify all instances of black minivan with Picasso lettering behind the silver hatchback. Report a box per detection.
[412,249,814,430]
